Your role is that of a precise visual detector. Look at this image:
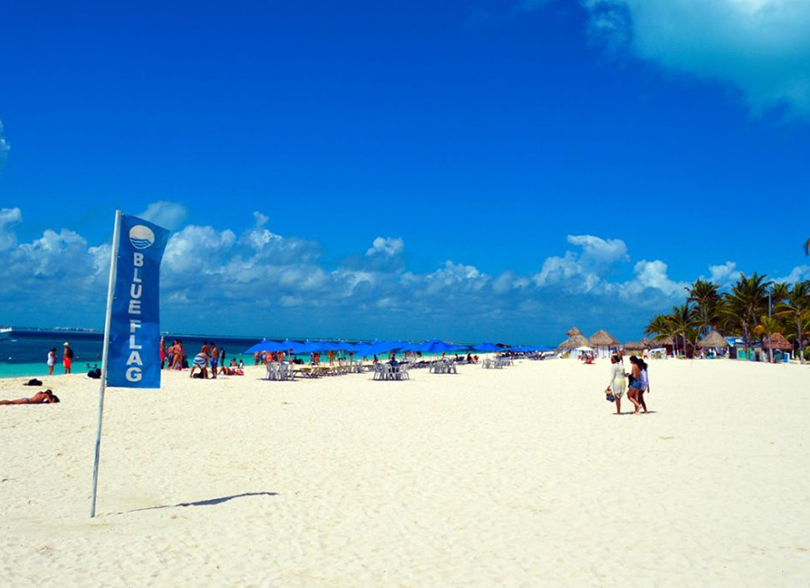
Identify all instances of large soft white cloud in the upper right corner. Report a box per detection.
[581,0,810,117]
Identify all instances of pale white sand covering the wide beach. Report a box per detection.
[0,360,810,588]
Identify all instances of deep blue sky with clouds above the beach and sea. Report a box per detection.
[0,0,810,343]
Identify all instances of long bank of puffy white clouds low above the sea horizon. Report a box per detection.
[0,208,810,343]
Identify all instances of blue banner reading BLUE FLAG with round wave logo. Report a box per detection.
[107,214,169,388]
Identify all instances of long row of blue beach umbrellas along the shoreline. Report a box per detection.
[245,339,552,357]
